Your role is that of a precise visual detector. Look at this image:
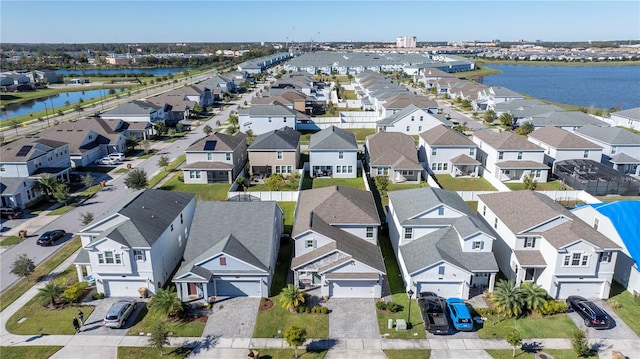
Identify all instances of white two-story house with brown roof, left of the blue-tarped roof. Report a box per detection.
[478,191,620,299]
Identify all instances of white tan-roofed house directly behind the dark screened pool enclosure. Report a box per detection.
[528,126,602,168]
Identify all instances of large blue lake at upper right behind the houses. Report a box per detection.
[483,65,640,110]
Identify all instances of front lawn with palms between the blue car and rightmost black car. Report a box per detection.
[478,314,578,339]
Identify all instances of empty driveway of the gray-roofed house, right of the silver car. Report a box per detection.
[202,297,260,338]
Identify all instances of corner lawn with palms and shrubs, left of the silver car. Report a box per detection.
[6,265,95,335]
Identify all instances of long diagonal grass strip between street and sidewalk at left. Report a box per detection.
[0,236,82,317]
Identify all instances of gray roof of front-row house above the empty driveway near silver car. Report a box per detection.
[176,201,280,277]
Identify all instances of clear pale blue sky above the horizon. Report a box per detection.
[0,0,640,43]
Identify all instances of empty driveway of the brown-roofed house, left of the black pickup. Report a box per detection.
[325,298,380,339]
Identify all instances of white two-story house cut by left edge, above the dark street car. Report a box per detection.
[0,137,71,208]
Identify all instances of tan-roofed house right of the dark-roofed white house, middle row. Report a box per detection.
[364,132,423,183]
